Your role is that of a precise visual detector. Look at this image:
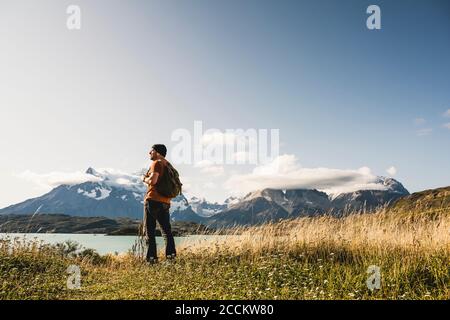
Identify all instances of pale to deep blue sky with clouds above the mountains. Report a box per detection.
[0,0,450,207]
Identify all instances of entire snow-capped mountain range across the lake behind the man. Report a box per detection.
[0,168,409,228]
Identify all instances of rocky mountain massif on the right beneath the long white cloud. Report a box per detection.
[204,177,409,228]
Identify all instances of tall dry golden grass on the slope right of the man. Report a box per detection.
[177,208,450,255]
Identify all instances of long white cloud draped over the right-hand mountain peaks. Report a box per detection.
[224,154,386,195]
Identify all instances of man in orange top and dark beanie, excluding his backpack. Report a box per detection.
[144,144,176,263]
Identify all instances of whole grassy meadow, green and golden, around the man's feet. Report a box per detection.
[0,208,450,299]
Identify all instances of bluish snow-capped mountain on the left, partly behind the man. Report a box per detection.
[0,168,209,221]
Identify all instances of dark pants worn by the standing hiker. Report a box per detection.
[144,200,176,261]
